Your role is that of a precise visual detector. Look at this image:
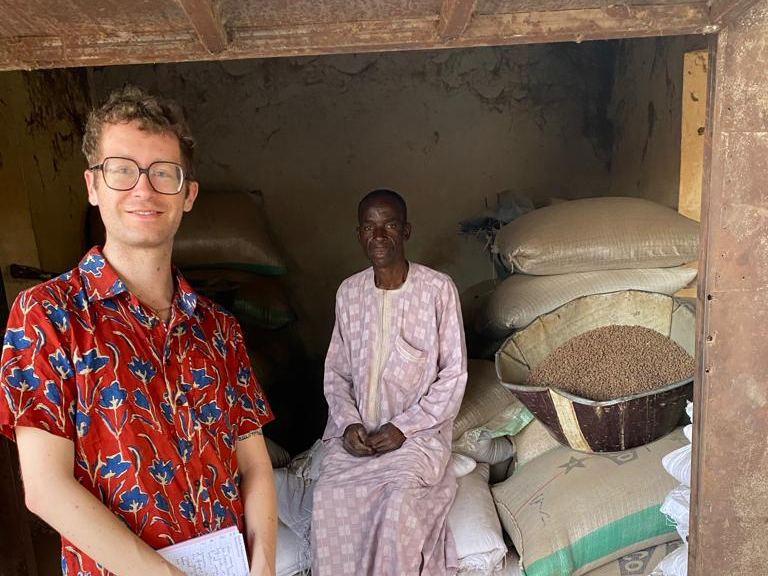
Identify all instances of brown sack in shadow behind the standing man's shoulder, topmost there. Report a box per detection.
[173,192,285,275]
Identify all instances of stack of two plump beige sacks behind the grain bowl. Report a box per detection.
[475,198,699,341]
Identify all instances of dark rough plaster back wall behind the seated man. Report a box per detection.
[92,43,613,356]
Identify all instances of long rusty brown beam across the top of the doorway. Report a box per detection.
[0,2,718,70]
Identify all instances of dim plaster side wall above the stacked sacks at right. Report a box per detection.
[610,36,706,208]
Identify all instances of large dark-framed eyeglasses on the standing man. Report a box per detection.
[88,156,185,194]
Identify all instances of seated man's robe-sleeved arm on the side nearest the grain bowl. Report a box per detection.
[391,282,467,437]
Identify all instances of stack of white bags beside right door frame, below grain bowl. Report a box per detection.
[651,402,693,576]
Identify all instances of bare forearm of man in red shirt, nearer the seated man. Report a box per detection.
[240,431,277,576]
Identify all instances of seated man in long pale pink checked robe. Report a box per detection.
[312,190,467,576]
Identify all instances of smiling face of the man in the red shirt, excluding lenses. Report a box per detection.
[85,122,198,248]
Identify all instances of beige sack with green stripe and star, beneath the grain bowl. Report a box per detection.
[491,429,686,576]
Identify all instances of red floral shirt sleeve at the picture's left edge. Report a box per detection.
[0,287,76,440]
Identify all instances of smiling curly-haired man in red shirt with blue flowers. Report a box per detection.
[0,87,277,576]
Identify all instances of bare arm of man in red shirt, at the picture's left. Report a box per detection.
[16,426,184,576]
